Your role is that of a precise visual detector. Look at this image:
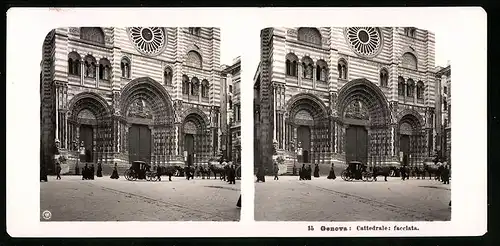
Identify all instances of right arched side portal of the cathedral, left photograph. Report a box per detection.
[179,111,211,165]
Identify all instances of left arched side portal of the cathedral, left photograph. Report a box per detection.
[67,92,113,163]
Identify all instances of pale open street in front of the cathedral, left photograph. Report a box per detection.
[40,176,240,221]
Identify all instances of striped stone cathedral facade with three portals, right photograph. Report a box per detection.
[254,27,436,173]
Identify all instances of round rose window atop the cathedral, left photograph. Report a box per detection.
[128,27,166,56]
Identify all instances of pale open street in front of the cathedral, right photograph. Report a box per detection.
[255,176,451,221]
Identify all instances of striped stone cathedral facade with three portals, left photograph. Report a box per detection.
[40,27,225,173]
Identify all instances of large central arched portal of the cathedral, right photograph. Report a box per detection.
[337,78,393,166]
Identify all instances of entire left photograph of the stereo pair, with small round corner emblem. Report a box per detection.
[40,27,241,221]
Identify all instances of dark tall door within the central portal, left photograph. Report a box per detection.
[128,124,151,163]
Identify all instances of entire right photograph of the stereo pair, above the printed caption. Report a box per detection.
[254,27,451,221]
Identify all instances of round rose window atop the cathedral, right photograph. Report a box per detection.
[345,27,382,57]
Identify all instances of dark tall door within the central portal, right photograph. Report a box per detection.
[346,125,368,164]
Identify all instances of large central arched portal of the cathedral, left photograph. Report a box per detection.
[116,77,179,165]
